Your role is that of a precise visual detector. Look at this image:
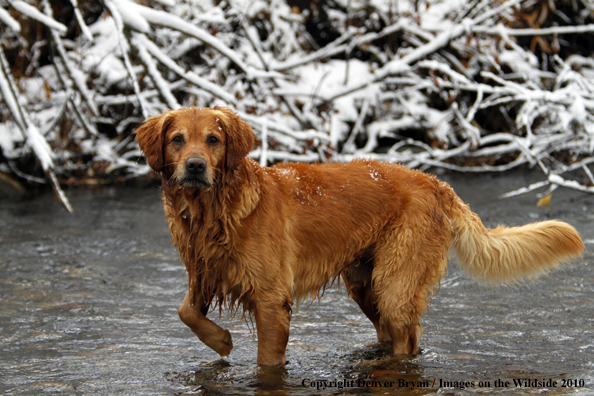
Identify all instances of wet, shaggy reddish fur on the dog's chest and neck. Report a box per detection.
[163,174,259,308]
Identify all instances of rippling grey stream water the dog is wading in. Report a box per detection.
[0,172,594,395]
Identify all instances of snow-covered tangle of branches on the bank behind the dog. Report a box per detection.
[0,0,594,210]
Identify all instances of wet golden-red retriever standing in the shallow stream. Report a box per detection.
[136,107,584,366]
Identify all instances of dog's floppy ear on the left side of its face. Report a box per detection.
[135,111,173,173]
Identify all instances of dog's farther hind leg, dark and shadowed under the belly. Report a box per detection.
[342,255,392,341]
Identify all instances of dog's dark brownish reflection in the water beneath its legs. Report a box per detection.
[169,343,438,395]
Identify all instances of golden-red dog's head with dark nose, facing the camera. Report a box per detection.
[136,107,255,189]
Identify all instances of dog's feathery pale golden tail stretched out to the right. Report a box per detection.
[449,193,584,284]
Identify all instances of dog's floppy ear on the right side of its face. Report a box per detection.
[214,106,256,170]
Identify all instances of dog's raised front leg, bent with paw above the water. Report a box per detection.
[178,289,233,357]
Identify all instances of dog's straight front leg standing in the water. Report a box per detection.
[254,299,292,366]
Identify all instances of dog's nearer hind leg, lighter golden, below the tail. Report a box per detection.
[372,216,450,355]
